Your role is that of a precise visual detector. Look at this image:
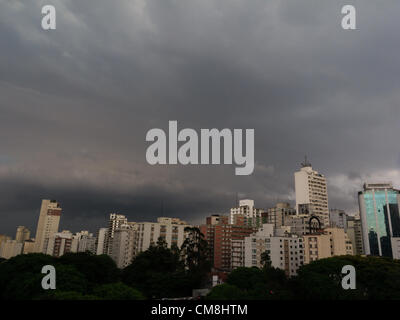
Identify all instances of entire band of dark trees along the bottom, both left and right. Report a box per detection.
[0,235,400,300]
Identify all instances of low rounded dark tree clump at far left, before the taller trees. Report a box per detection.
[0,253,143,300]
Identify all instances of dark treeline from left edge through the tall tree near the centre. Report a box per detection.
[0,228,211,300]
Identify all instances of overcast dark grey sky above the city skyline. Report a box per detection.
[0,0,400,235]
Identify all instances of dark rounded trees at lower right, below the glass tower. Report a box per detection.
[207,256,400,300]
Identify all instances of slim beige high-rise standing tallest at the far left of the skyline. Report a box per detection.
[35,200,62,253]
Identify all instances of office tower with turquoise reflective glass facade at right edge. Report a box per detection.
[358,183,400,258]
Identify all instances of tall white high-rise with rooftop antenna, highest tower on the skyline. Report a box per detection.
[294,159,329,227]
